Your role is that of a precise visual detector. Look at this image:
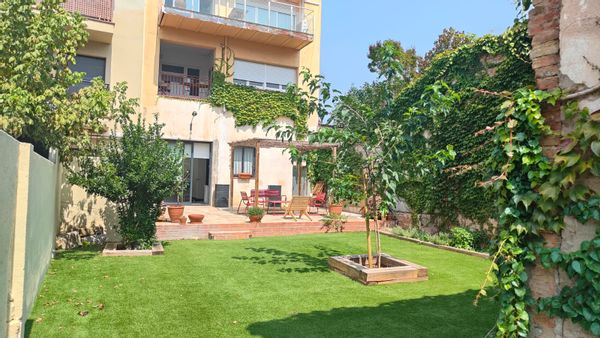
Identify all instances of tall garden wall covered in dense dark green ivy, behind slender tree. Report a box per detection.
[395,23,534,226]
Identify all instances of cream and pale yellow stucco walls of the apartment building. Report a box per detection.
[60,0,321,232]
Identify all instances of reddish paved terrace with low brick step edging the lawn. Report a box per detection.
[156,205,365,240]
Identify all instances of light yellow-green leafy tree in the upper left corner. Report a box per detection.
[0,0,111,160]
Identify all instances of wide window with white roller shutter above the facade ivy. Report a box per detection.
[233,60,296,91]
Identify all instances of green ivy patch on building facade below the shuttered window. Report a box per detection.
[208,73,308,129]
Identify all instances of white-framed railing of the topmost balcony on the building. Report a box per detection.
[165,0,314,35]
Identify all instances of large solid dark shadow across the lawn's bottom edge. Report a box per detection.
[246,286,498,338]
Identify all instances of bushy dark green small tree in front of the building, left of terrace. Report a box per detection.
[69,85,183,248]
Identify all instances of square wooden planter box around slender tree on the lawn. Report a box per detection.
[328,254,428,285]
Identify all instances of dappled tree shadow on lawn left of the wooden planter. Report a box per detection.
[232,245,342,273]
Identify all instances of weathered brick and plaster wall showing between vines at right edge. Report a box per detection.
[529,0,600,338]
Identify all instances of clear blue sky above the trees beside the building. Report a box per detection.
[321,0,517,92]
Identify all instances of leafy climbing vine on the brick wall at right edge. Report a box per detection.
[480,89,600,337]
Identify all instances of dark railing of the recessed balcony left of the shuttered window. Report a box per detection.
[158,72,210,99]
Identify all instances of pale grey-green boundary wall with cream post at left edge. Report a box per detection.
[0,131,60,337]
